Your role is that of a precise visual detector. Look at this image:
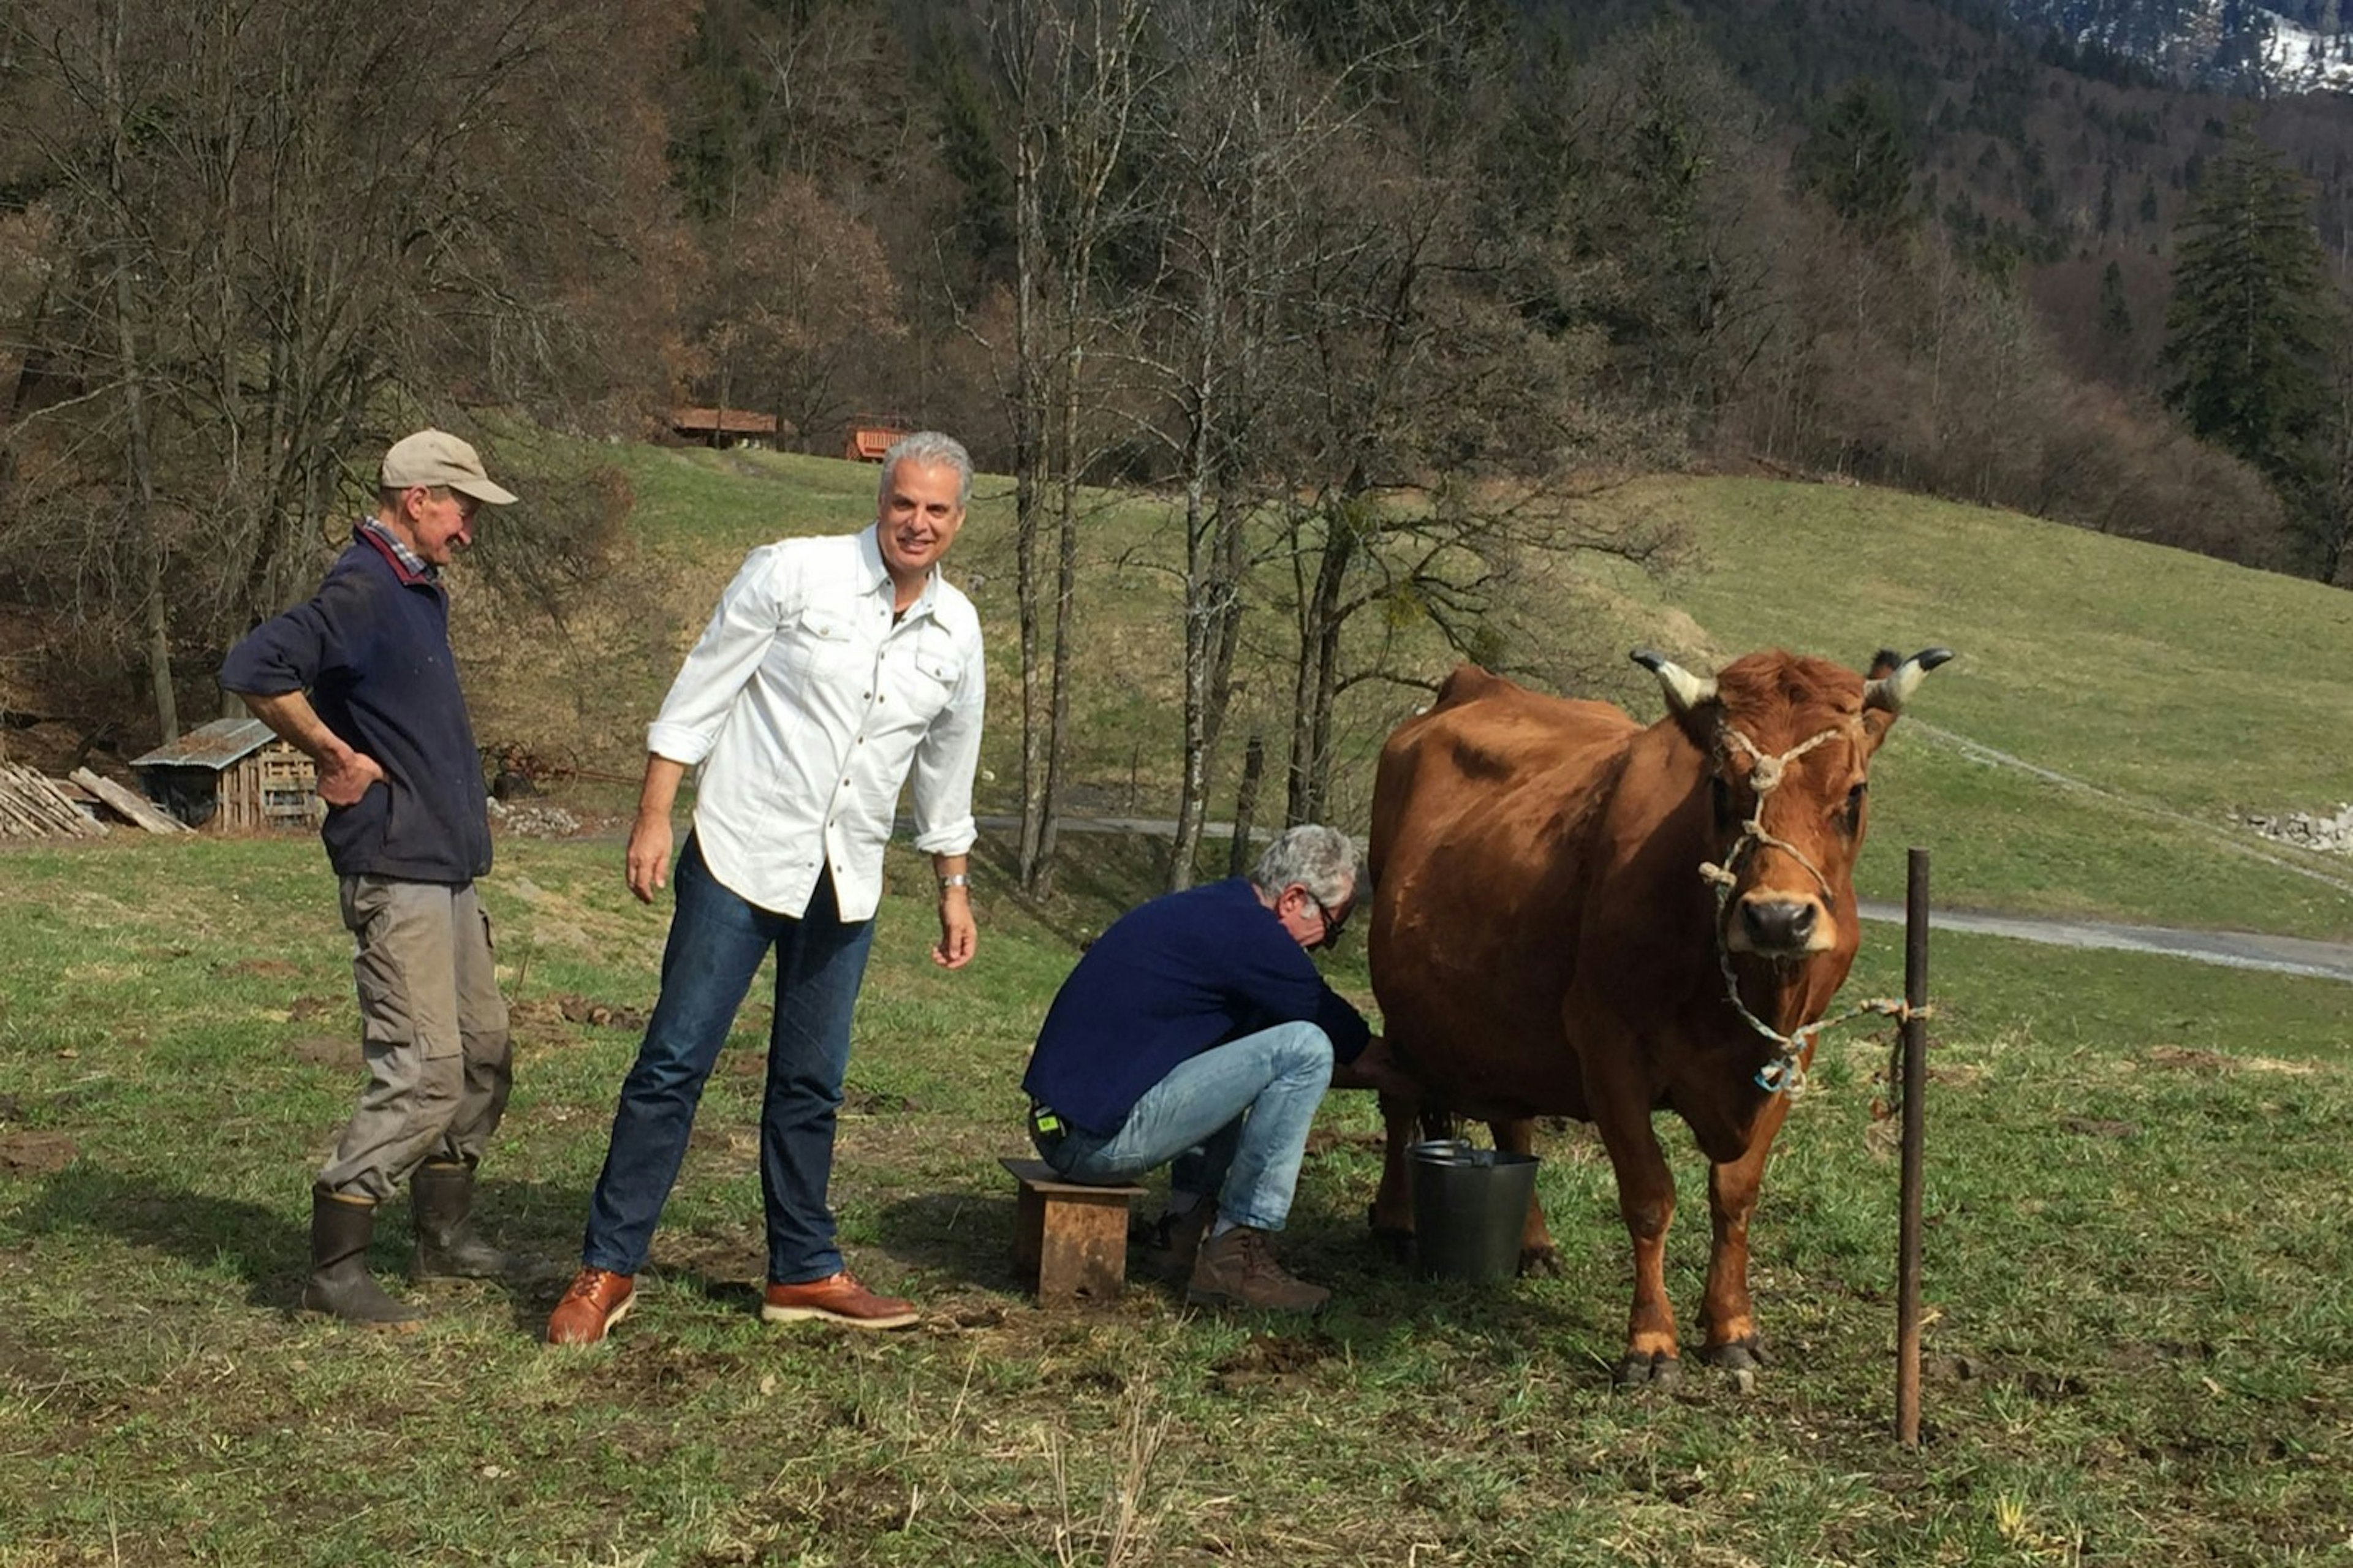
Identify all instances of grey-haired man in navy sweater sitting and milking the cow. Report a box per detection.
[1021,824,1390,1311]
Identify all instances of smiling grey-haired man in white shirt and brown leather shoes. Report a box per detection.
[548,431,983,1344]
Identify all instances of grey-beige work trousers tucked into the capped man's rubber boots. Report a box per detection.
[317,876,513,1203]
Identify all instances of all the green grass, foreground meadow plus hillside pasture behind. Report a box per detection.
[0,450,2353,1568]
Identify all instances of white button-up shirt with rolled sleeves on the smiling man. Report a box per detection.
[645,528,983,920]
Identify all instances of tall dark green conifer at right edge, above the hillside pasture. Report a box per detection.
[2158,123,2339,511]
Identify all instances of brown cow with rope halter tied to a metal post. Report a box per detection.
[1372,648,1953,1382]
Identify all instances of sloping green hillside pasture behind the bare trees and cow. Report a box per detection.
[459,447,2353,939]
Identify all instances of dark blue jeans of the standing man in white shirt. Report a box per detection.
[581,833,873,1286]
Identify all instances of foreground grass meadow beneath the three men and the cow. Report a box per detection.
[0,824,2353,1568]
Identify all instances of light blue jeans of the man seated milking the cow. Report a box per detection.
[1037,1024,1332,1232]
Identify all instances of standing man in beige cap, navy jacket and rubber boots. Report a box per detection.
[221,431,515,1330]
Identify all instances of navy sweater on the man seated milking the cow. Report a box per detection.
[1021,878,1372,1137]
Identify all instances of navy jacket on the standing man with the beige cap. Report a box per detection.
[221,530,490,883]
